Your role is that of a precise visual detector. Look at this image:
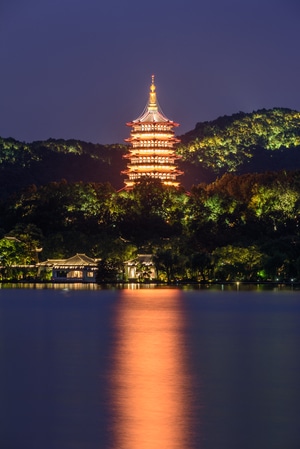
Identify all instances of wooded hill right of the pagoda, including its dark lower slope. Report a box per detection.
[178,108,300,185]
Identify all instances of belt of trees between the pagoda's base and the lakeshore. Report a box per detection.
[0,171,300,282]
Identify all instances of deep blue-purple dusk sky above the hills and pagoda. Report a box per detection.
[0,0,300,143]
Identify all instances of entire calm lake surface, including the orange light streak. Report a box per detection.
[0,288,300,449]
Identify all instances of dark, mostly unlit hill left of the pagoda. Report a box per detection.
[0,138,126,195]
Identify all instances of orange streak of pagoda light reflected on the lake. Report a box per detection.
[113,289,192,449]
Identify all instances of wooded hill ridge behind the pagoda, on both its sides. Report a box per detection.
[0,108,300,196]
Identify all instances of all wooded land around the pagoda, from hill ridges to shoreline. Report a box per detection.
[0,108,300,282]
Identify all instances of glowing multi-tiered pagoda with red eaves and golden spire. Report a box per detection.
[123,75,182,188]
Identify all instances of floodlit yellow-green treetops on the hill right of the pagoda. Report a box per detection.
[178,108,300,173]
